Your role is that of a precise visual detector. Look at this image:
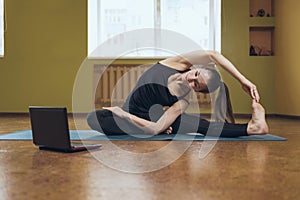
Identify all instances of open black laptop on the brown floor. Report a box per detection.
[29,106,101,152]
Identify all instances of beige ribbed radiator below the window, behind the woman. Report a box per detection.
[94,64,211,108]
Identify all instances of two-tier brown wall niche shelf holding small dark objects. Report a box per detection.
[249,0,275,56]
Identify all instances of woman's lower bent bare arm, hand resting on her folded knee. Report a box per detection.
[103,100,188,134]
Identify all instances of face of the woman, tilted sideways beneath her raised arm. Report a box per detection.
[184,68,210,92]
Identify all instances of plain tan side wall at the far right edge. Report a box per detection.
[275,0,300,116]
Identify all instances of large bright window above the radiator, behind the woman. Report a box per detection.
[88,0,221,58]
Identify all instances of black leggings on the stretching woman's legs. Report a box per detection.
[87,110,248,137]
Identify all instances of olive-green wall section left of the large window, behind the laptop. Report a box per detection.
[0,0,87,112]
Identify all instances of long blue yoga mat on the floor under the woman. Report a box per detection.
[0,130,287,141]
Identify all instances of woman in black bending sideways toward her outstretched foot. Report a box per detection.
[87,51,269,137]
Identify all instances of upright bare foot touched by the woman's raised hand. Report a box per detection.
[247,100,269,135]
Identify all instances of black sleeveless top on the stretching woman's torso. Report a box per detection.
[123,63,188,121]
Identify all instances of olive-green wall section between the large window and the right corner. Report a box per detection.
[222,0,275,113]
